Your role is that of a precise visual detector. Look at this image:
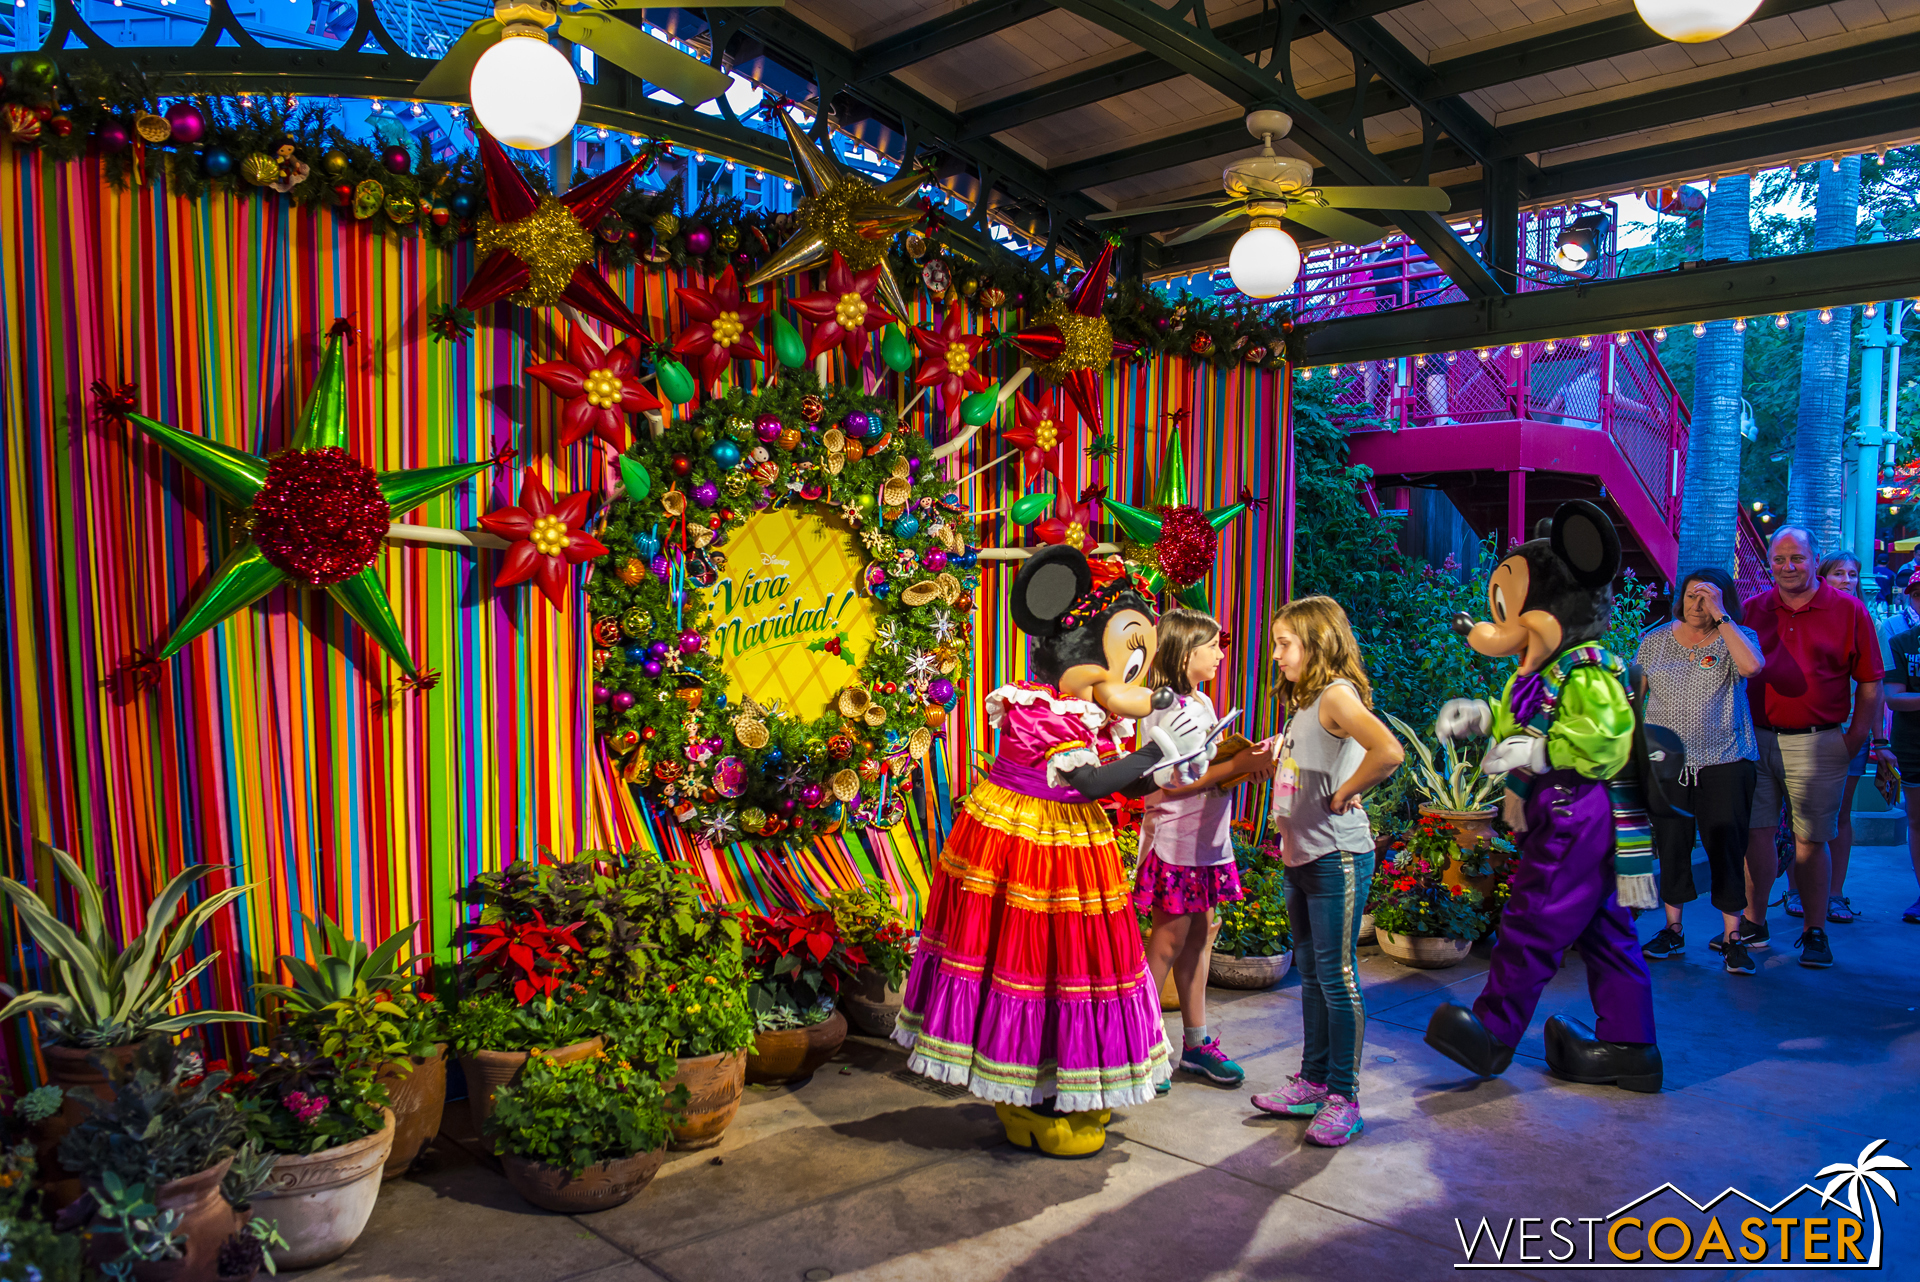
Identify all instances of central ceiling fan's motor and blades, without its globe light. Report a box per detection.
[1087,111,1452,246]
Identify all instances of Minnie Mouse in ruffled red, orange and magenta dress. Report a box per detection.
[893,547,1208,1157]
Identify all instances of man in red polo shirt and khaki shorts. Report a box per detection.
[1740,526,1884,967]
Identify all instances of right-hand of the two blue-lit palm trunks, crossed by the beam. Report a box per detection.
[1788,155,1860,557]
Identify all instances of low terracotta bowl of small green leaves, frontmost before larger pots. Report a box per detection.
[488,1052,668,1215]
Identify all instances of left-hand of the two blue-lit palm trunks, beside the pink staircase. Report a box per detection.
[1680,173,1753,574]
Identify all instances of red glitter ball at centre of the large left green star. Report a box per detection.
[253,449,390,587]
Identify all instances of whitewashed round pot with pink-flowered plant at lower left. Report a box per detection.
[225,1034,394,1269]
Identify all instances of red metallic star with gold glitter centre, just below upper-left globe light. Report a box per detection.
[457,132,653,337]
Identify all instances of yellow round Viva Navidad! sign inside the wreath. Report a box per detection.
[705,509,874,720]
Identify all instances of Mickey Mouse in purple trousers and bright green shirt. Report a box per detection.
[1427,501,1661,1092]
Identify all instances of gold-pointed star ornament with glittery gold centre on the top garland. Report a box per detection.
[747,107,925,317]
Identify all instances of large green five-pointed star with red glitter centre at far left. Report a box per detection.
[113,321,493,681]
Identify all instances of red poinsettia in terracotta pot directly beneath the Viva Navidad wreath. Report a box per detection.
[741,908,866,1086]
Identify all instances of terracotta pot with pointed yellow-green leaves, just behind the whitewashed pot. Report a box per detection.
[255,914,447,1178]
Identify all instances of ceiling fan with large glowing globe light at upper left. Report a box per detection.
[413,0,783,150]
